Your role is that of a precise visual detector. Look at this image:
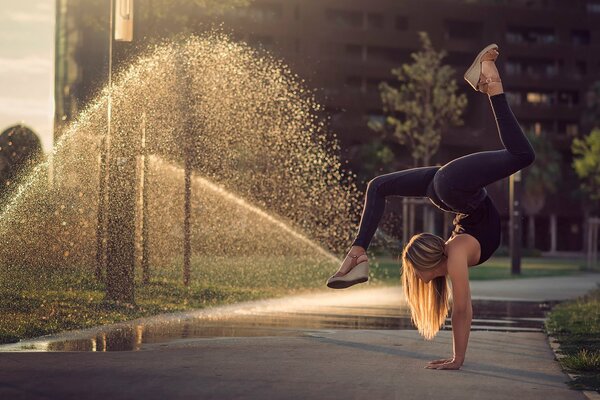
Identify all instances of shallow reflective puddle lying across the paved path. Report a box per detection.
[0,300,557,351]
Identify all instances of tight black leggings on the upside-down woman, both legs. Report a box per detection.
[352,93,535,249]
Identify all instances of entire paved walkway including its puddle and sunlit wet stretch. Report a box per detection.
[0,274,600,400]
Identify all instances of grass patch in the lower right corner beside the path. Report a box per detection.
[546,288,600,392]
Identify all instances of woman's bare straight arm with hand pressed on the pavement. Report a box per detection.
[426,249,473,369]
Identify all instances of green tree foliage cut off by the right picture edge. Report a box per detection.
[571,128,600,212]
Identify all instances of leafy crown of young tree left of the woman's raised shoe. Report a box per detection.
[369,32,467,167]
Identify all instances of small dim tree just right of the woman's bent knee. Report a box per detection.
[522,132,561,248]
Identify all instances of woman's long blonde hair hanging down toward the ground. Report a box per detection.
[401,232,449,340]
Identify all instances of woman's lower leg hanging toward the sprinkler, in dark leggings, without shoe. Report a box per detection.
[352,166,440,250]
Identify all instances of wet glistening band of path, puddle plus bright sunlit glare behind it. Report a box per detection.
[0,283,572,351]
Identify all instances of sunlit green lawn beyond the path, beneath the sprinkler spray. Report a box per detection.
[0,256,592,343]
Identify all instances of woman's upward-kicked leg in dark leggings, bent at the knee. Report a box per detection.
[434,93,535,206]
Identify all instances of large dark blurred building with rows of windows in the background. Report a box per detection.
[56,0,600,252]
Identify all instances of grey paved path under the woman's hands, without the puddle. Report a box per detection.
[0,274,600,400]
